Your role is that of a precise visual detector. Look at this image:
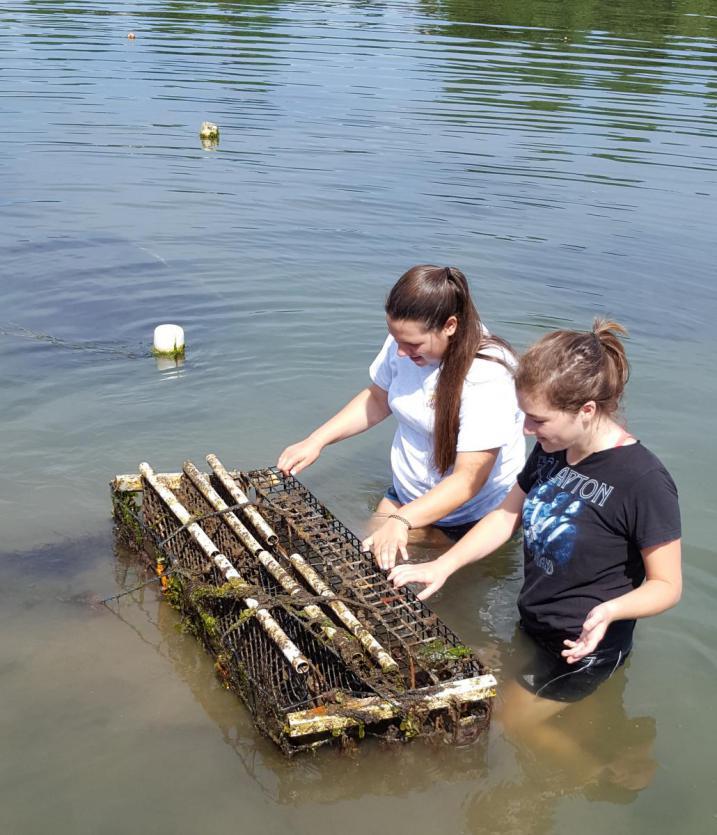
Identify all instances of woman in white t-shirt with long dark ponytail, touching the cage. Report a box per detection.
[277,265,525,569]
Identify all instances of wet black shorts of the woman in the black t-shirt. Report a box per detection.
[516,633,630,702]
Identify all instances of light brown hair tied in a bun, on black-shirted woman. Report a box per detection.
[515,319,630,417]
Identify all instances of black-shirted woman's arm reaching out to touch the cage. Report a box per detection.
[388,484,525,600]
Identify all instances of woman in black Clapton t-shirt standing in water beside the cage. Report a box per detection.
[389,320,682,722]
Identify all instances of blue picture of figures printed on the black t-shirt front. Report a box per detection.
[523,481,583,574]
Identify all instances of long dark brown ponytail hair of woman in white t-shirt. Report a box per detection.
[386,264,513,474]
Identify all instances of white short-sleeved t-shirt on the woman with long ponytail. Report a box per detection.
[369,335,525,525]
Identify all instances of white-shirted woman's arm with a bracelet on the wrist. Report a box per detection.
[362,449,498,569]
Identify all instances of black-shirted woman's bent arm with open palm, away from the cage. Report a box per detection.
[562,539,682,664]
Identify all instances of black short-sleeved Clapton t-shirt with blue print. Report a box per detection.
[518,443,681,652]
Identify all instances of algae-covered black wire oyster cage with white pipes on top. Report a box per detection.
[110,455,496,754]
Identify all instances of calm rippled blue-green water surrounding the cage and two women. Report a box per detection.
[0,0,717,835]
